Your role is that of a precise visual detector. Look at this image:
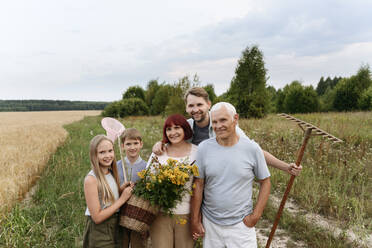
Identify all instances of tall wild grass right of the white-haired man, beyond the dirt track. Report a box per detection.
[240,112,372,233]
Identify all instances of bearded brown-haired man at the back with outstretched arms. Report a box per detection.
[153,87,302,176]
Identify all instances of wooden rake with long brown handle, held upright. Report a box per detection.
[266,114,343,248]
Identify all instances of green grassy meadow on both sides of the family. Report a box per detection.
[0,112,372,247]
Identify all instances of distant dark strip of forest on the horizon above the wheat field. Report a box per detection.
[0,100,109,112]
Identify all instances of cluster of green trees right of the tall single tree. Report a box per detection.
[270,65,372,113]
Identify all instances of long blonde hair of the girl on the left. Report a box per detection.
[89,134,120,205]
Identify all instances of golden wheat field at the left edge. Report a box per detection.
[0,111,101,210]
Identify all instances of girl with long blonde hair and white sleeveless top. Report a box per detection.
[83,135,133,248]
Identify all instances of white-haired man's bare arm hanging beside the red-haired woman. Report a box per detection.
[190,178,205,240]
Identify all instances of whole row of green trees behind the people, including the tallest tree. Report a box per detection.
[103,46,372,118]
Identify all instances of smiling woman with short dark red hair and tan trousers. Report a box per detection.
[148,114,197,248]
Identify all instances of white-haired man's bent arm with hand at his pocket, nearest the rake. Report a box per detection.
[243,177,271,227]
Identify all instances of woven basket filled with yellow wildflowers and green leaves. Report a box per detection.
[119,156,199,233]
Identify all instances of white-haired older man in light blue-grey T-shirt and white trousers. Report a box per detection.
[190,102,271,248]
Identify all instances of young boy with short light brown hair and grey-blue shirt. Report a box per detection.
[117,128,147,248]
